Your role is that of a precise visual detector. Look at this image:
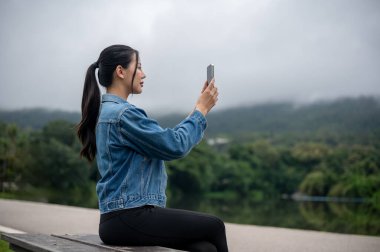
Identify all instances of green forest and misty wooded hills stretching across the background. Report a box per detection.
[0,97,380,211]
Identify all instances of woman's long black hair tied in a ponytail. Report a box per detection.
[77,45,139,162]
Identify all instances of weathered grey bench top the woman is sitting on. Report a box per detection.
[1,233,180,252]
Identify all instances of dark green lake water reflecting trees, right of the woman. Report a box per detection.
[169,198,380,236]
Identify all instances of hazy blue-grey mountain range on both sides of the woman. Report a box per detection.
[0,97,380,136]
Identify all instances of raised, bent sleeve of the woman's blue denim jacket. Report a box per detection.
[120,108,207,160]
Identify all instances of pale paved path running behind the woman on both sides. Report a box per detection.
[0,199,380,252]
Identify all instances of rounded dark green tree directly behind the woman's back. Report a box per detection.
[20,121,96,206]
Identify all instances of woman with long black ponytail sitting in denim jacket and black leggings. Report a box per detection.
[77,45,228,251]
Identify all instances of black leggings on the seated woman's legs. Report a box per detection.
[99,206,228,252]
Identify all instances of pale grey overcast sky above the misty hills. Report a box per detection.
[0,0,380,114]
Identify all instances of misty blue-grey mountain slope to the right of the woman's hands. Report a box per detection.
[209,97,380,136]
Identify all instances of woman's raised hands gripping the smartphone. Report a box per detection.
[195,79,219,115]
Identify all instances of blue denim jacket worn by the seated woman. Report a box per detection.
[96,94,207,213]
